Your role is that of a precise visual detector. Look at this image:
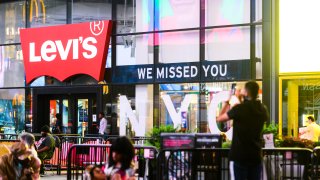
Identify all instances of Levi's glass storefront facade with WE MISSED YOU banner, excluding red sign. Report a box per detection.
[0,0,268,135]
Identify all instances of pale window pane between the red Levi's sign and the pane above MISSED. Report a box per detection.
[117,34,153,66]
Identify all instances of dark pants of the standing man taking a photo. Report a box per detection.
[233,161,262,180]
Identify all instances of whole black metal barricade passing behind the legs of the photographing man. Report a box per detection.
[158,148,312,180]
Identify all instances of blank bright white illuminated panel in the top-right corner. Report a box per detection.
[279,0,320,73]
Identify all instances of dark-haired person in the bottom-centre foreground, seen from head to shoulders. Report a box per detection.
[105,136,135,180]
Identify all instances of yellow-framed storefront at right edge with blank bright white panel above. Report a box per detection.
[277,0,320,137]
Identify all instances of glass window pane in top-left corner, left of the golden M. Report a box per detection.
[0,1,25,44]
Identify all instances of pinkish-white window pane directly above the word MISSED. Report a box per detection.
[159,31,199,63]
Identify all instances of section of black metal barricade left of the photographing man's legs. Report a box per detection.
[158,148,230,180]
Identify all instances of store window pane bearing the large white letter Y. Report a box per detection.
[159,83,199,132]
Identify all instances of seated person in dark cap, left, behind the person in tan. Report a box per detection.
[36,125,55,174]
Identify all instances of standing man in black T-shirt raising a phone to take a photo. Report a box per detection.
[217,81,269,180]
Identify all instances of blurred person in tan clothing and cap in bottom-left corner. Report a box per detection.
[0,142,40,180]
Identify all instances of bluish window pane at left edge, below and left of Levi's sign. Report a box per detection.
[0,89,25,134]
